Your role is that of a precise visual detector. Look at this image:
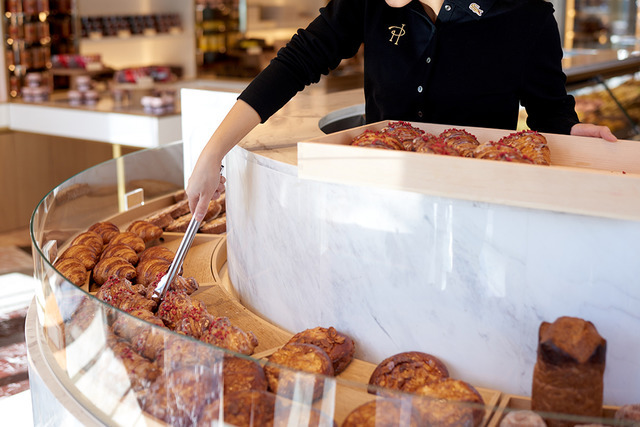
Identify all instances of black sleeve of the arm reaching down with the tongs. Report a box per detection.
[238,0,366,123]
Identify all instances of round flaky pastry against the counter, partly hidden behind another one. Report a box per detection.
[289,326,356,375]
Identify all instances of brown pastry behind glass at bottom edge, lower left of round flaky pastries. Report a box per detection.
[198,390,277,427]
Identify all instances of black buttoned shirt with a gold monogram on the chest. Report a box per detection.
[239,0,578,134]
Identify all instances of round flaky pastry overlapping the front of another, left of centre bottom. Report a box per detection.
[264,343,334,400]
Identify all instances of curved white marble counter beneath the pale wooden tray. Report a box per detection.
[182,90,640,405]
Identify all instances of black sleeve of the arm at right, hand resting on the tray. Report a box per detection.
[521,7,579,135]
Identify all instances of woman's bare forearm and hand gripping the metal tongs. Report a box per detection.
[186,100,260,221]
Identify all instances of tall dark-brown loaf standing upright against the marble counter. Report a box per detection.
[531,316,607,426]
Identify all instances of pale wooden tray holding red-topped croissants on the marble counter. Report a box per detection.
[298,121,640,221]
